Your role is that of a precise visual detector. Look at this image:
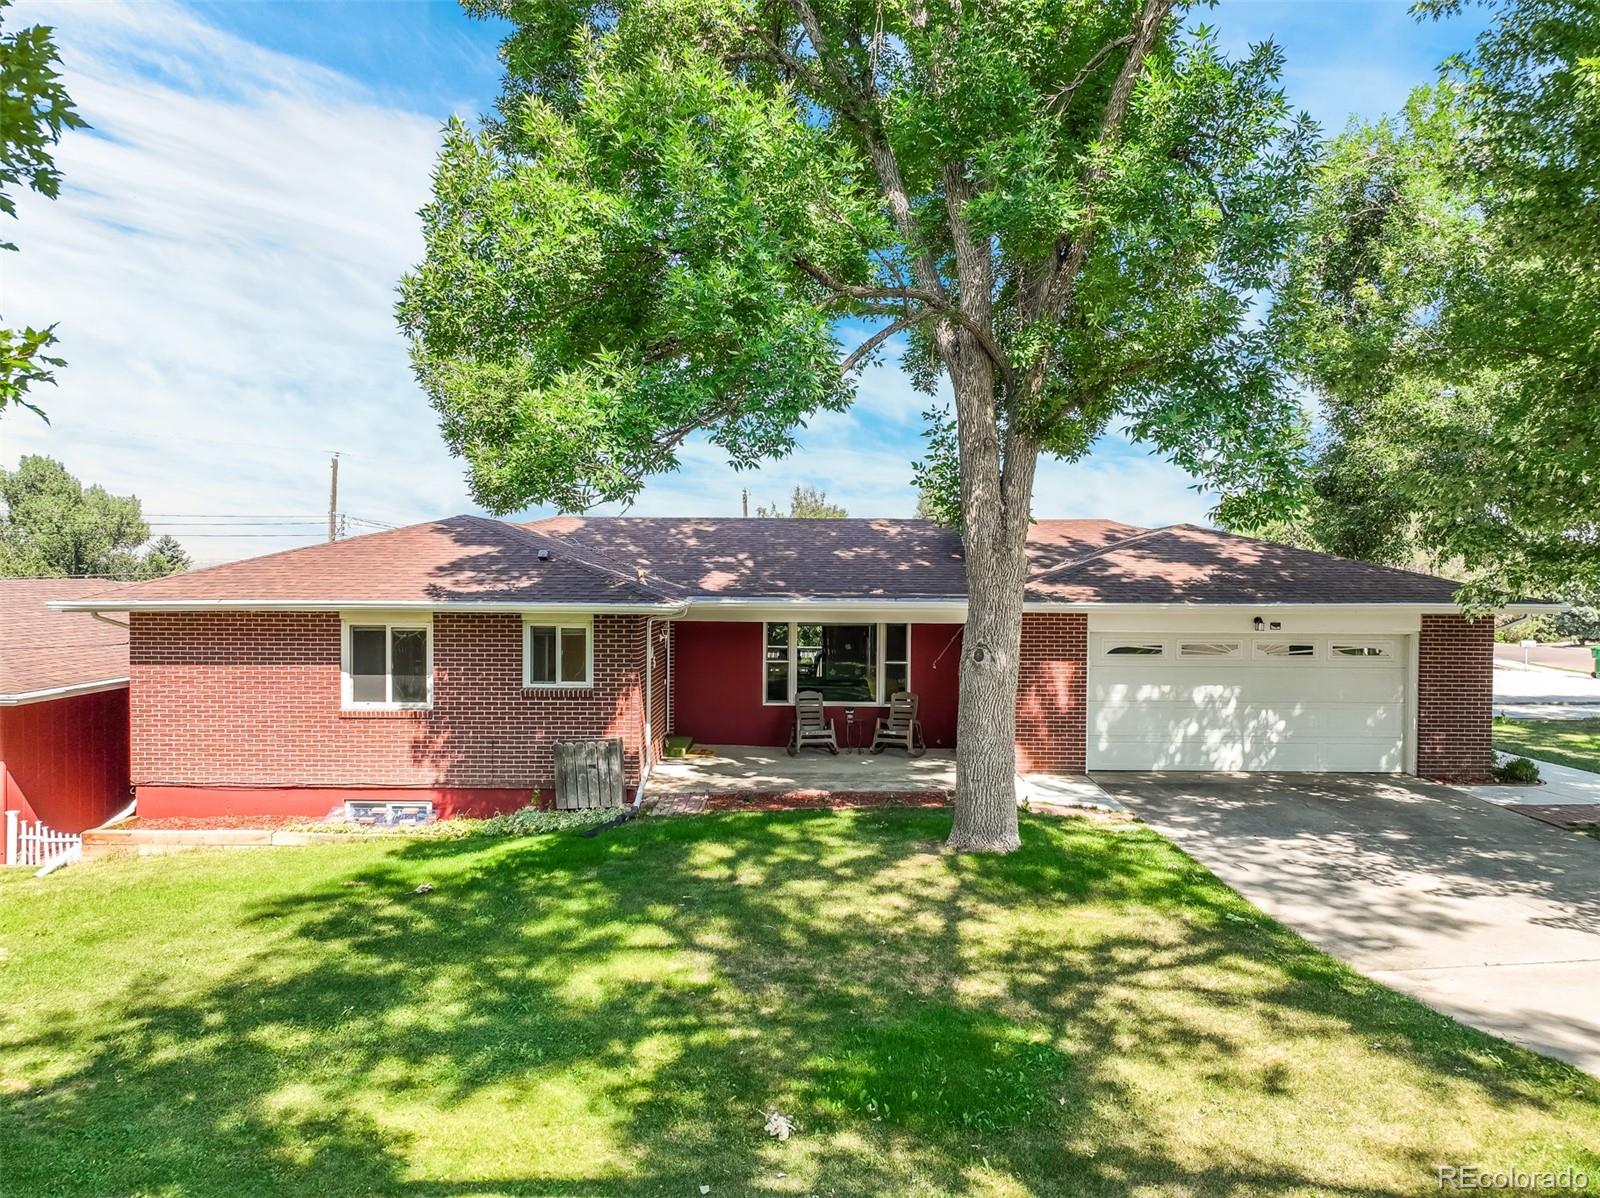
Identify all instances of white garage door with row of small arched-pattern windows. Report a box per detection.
[1088,633,1406,773]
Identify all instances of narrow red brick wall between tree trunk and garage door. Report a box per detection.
[1016,611,1090,774]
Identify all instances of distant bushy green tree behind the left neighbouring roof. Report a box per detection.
[0,454,189,579]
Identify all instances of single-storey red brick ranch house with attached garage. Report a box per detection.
[56,517,1493,816]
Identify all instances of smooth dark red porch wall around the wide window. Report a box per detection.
[672,621,962,749]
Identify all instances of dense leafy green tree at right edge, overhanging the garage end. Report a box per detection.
[1235,0,1600,603]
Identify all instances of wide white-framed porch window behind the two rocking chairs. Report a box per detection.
[762,621,910,705]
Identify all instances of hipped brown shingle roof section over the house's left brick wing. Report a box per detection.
[60,515,672,605]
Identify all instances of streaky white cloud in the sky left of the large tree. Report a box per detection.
[3,3,469,560]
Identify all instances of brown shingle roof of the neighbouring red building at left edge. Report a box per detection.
[0,577,128,699]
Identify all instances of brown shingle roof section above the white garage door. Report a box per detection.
[1027,525,1458,603]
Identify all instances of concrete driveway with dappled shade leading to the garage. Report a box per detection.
[1094,774,1600,1075]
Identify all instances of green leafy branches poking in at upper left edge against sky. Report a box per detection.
[0,0,86,416]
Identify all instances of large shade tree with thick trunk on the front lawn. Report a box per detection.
[400,0,1315,851]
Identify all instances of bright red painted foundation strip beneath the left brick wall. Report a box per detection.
[138,787,555,819]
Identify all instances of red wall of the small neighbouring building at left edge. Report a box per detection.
[0,688,130,832]
